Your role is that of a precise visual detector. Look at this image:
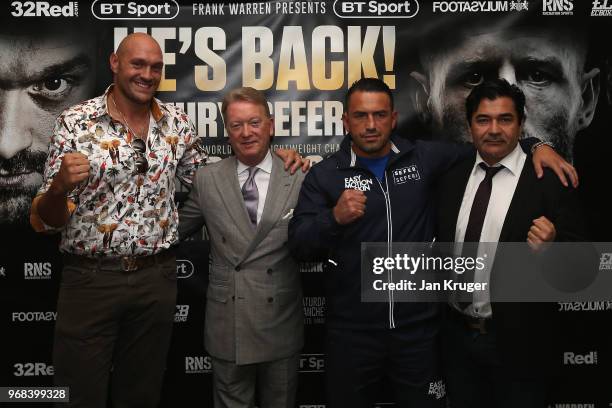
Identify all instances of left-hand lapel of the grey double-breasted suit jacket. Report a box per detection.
[213,156,255,240]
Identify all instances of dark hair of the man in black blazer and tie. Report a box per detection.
[465,78,525,123]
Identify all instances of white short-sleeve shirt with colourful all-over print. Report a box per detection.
[39,87,206,257]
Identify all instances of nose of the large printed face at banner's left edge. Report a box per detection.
[0,89,36,160]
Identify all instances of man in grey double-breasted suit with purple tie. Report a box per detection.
[179,88,304,408]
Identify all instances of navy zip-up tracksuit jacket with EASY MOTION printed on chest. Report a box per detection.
[289,135,473,329]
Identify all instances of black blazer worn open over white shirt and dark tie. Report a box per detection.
[437,153,585,375]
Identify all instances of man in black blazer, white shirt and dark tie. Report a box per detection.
[437,79,584,408]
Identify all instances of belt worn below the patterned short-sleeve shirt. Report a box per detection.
[63,248,175,272]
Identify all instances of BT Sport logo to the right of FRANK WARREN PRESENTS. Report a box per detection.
[334,0,419,18]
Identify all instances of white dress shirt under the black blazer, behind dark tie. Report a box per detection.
[455,144,527,318]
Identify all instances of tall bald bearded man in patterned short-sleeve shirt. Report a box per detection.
[31,33,304,408]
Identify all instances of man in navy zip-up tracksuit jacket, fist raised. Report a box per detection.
[289,78,572,408]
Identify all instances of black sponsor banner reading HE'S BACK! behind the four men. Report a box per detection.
[0,0,612,408]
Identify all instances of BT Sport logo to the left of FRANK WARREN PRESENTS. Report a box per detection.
[91,0,179,20]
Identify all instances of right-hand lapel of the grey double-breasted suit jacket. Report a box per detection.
[241,153,294,262]
